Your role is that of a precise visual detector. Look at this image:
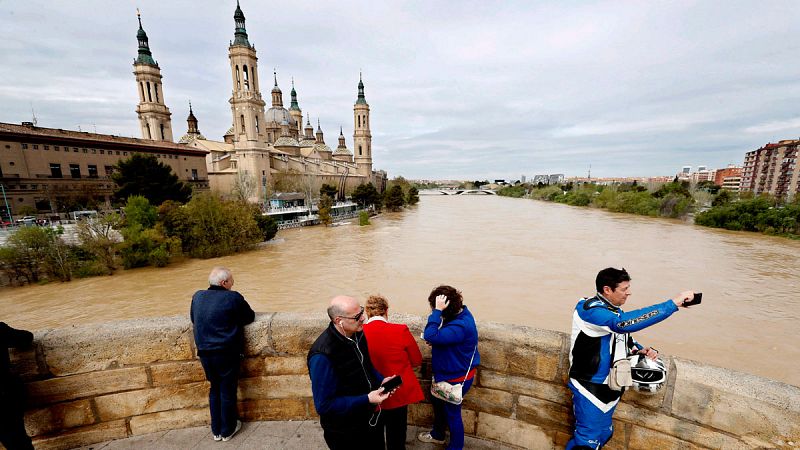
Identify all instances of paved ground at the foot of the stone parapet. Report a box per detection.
[80,420,513,450]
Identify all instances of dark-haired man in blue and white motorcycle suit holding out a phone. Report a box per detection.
[566,267,694,450]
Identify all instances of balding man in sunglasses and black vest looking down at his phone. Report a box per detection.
[307,295,393,450]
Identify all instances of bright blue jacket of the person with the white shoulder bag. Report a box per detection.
[423,306,481,381]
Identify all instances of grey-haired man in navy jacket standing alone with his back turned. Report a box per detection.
[190,267,255,441]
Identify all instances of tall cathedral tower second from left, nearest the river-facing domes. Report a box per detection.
[228,1,266,150]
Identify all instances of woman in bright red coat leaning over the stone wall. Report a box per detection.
[364,295,425,450]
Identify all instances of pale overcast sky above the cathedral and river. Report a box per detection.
[0,0,800,179]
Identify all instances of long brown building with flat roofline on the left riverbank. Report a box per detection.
[0,122,209,219]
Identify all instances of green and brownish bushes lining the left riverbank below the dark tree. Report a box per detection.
[0,193,278,284]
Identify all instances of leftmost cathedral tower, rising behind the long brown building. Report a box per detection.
[133,10,172,142]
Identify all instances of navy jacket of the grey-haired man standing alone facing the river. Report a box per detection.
[189,286,256,356]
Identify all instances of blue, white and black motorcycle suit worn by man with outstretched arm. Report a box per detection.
[567,294,678,450]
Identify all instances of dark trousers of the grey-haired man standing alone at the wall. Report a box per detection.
[200,353,240,437]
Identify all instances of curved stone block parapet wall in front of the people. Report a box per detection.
[7,313,800,449]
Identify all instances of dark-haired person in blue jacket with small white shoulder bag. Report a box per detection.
[417,286,481,450]
